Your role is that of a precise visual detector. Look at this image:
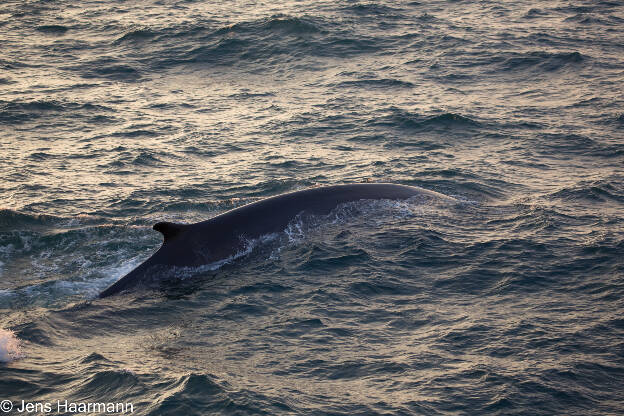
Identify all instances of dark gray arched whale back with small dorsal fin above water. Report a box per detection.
[99,183,454,298]
